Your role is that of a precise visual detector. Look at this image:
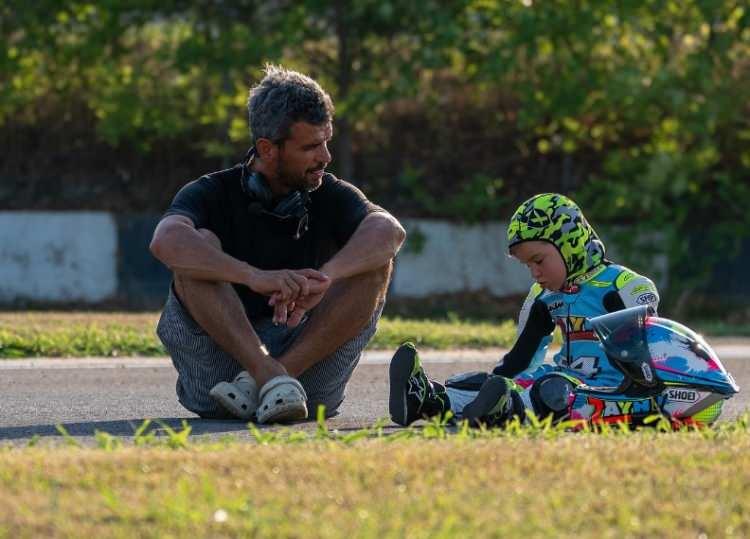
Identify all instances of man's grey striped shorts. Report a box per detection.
[156,287,383,418]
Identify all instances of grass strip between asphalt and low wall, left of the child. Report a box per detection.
[0,312,516,358]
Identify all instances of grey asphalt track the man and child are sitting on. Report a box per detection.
[0,346,750,445]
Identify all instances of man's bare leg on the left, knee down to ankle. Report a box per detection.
[174,229,288,387]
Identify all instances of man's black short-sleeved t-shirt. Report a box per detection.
[164,167,383,319]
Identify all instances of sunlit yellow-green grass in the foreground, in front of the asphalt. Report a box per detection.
[0,417,750,538]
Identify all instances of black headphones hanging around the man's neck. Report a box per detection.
[239,147,310,240]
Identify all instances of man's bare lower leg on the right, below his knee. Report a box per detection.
[278,263,392,378]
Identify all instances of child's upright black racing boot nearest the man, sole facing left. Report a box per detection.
[388,342,450,426]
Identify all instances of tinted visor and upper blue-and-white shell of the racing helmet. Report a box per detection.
[590,306,739,395]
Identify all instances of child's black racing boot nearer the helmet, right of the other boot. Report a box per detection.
[462,374,526,428]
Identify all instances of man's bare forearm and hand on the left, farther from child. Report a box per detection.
[150,215,325,300]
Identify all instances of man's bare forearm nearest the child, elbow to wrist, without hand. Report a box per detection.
[320,211,406,281]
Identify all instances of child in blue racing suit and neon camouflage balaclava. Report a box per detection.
[389,193,659,426]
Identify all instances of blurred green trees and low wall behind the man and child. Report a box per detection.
[0,0,750,324]
